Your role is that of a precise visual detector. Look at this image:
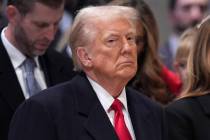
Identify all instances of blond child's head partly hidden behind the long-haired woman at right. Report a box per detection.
[174,28,196,92]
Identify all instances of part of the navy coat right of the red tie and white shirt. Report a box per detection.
[127,88,166,140]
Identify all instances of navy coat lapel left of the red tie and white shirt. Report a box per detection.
[76,75,118,140]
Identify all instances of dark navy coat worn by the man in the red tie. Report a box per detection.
[9,74,166,140]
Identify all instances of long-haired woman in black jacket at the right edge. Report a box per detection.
[166,16,210,140]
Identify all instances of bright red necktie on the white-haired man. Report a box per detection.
[111,99,132,140]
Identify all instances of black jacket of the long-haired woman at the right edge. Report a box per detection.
[166,95,210,140]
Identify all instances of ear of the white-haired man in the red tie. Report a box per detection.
[76,47,92,68]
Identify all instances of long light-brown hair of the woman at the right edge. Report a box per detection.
[181,16,210,97]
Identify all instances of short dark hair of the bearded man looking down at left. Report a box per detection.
[8,0,65,15]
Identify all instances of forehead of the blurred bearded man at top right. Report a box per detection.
[176,0,208,6]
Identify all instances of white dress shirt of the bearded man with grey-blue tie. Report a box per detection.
[1,28,47,99]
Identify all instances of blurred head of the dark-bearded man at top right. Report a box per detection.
[168,0,209,35]
